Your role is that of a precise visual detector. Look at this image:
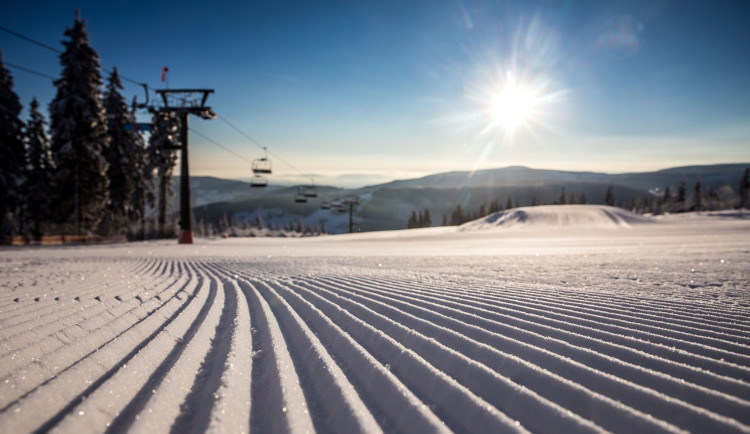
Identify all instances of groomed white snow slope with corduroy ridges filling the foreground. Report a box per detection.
[0,209,750,433]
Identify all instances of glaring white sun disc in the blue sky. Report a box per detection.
[488,74,540,135]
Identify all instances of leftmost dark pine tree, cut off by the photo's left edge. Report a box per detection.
[0,51,26,238]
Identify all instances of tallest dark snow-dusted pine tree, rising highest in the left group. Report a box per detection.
[49,13,109,234]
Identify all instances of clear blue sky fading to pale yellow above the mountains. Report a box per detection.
[0,0,750,184]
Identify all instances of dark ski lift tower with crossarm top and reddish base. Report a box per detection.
[156,89,216,244]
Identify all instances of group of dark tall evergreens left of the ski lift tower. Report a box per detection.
[0,14,179,241]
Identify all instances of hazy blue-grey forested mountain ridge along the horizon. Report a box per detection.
[175,163,750,233]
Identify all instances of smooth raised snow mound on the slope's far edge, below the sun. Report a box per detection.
[459,205,653,231]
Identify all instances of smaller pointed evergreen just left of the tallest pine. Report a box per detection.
[24,98,55,238]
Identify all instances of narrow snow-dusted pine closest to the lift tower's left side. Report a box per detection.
[148,112,180,236]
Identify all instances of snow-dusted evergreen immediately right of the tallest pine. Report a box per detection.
[104,68,146,233]
